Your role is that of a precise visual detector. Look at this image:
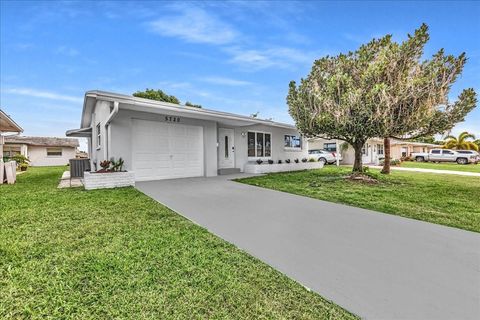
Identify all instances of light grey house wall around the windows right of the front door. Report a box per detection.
[232,125,308,172]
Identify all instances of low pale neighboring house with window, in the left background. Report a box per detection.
[3,136,79,166]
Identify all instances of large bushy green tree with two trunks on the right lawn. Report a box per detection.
[287,25,476,172]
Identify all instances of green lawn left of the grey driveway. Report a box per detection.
[0,167,355,319]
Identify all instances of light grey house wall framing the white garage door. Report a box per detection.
[108,110,218,177]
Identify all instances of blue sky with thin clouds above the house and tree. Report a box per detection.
[0,1,480,151]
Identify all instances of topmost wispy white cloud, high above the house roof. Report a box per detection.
[149,8,237,44]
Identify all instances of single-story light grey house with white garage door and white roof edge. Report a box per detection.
[67,91,308,180]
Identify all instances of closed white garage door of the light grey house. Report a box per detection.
[132,120,203,181]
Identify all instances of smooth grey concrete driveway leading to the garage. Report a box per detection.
[137,176,480,320]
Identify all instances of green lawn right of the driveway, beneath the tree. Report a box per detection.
[238,167,480,232]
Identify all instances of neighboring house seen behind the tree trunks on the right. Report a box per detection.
[308,138,439,164]
